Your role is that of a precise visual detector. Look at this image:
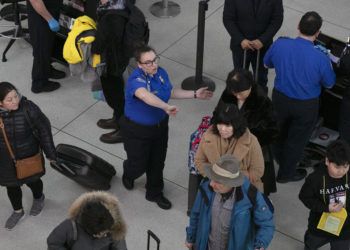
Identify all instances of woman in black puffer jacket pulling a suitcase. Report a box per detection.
[0,82,56,230]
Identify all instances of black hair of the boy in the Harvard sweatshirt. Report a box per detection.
[326,139,350,166]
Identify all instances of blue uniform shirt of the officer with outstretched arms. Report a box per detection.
[124,67,173,125]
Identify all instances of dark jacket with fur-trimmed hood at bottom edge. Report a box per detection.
[47,191,127,250]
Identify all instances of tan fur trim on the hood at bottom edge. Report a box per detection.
[69,191,126,240]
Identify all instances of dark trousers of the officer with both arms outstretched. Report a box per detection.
[120,117,169,199]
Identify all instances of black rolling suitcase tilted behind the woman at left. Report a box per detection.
[51,144,116,190]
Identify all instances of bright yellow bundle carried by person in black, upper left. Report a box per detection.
[63,16,96,64]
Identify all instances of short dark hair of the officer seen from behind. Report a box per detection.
[299,11,322,36]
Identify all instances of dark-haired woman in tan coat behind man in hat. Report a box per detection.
[195,103,264,192]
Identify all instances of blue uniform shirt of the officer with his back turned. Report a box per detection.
[264,37,335,100]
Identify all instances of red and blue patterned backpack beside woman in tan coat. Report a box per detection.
[188,116,211,175]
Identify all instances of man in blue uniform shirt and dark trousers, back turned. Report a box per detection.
[264,11,335,183]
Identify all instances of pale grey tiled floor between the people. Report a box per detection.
[0,0,350,250]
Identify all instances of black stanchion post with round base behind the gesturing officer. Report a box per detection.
[181,0,215,91]
